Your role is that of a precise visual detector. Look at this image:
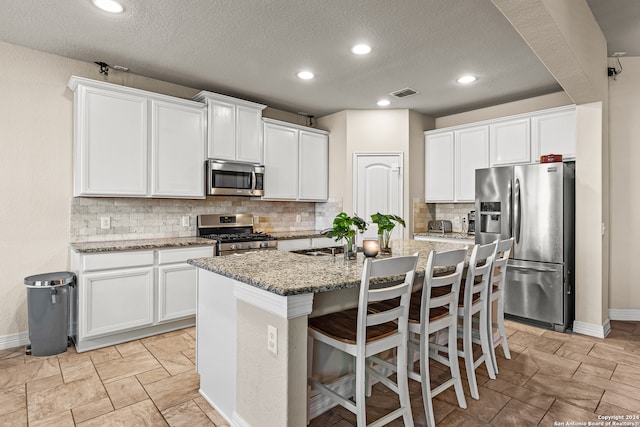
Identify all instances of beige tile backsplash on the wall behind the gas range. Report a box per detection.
[70,196,342,243]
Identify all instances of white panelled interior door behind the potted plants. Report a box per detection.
[353,153,404,240]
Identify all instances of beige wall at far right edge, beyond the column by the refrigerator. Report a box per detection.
[609,57,640,310]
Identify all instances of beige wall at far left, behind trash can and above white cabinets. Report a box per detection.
[0,42,298,345]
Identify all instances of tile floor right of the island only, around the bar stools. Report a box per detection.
[310,321,640,427]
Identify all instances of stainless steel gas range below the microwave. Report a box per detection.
[197,214,278,255]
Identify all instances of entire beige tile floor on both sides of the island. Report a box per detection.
[0,321,640,427]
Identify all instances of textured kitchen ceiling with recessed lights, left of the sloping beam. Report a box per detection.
[0,0,624,117]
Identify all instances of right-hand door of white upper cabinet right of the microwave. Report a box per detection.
[298,131,329,201]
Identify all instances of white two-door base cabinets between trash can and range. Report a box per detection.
[71,246,214,352]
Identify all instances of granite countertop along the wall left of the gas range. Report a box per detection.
[71,237,216,253]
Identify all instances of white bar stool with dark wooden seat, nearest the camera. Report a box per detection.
[309,253,418,427]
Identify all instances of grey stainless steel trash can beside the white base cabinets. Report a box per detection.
[24,271,76,356]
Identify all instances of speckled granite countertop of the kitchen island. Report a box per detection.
[188,240,472,296]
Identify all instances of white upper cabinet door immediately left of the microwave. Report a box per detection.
[151,101,205,199]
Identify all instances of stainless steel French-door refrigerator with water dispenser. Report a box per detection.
[475,162,575,331]
